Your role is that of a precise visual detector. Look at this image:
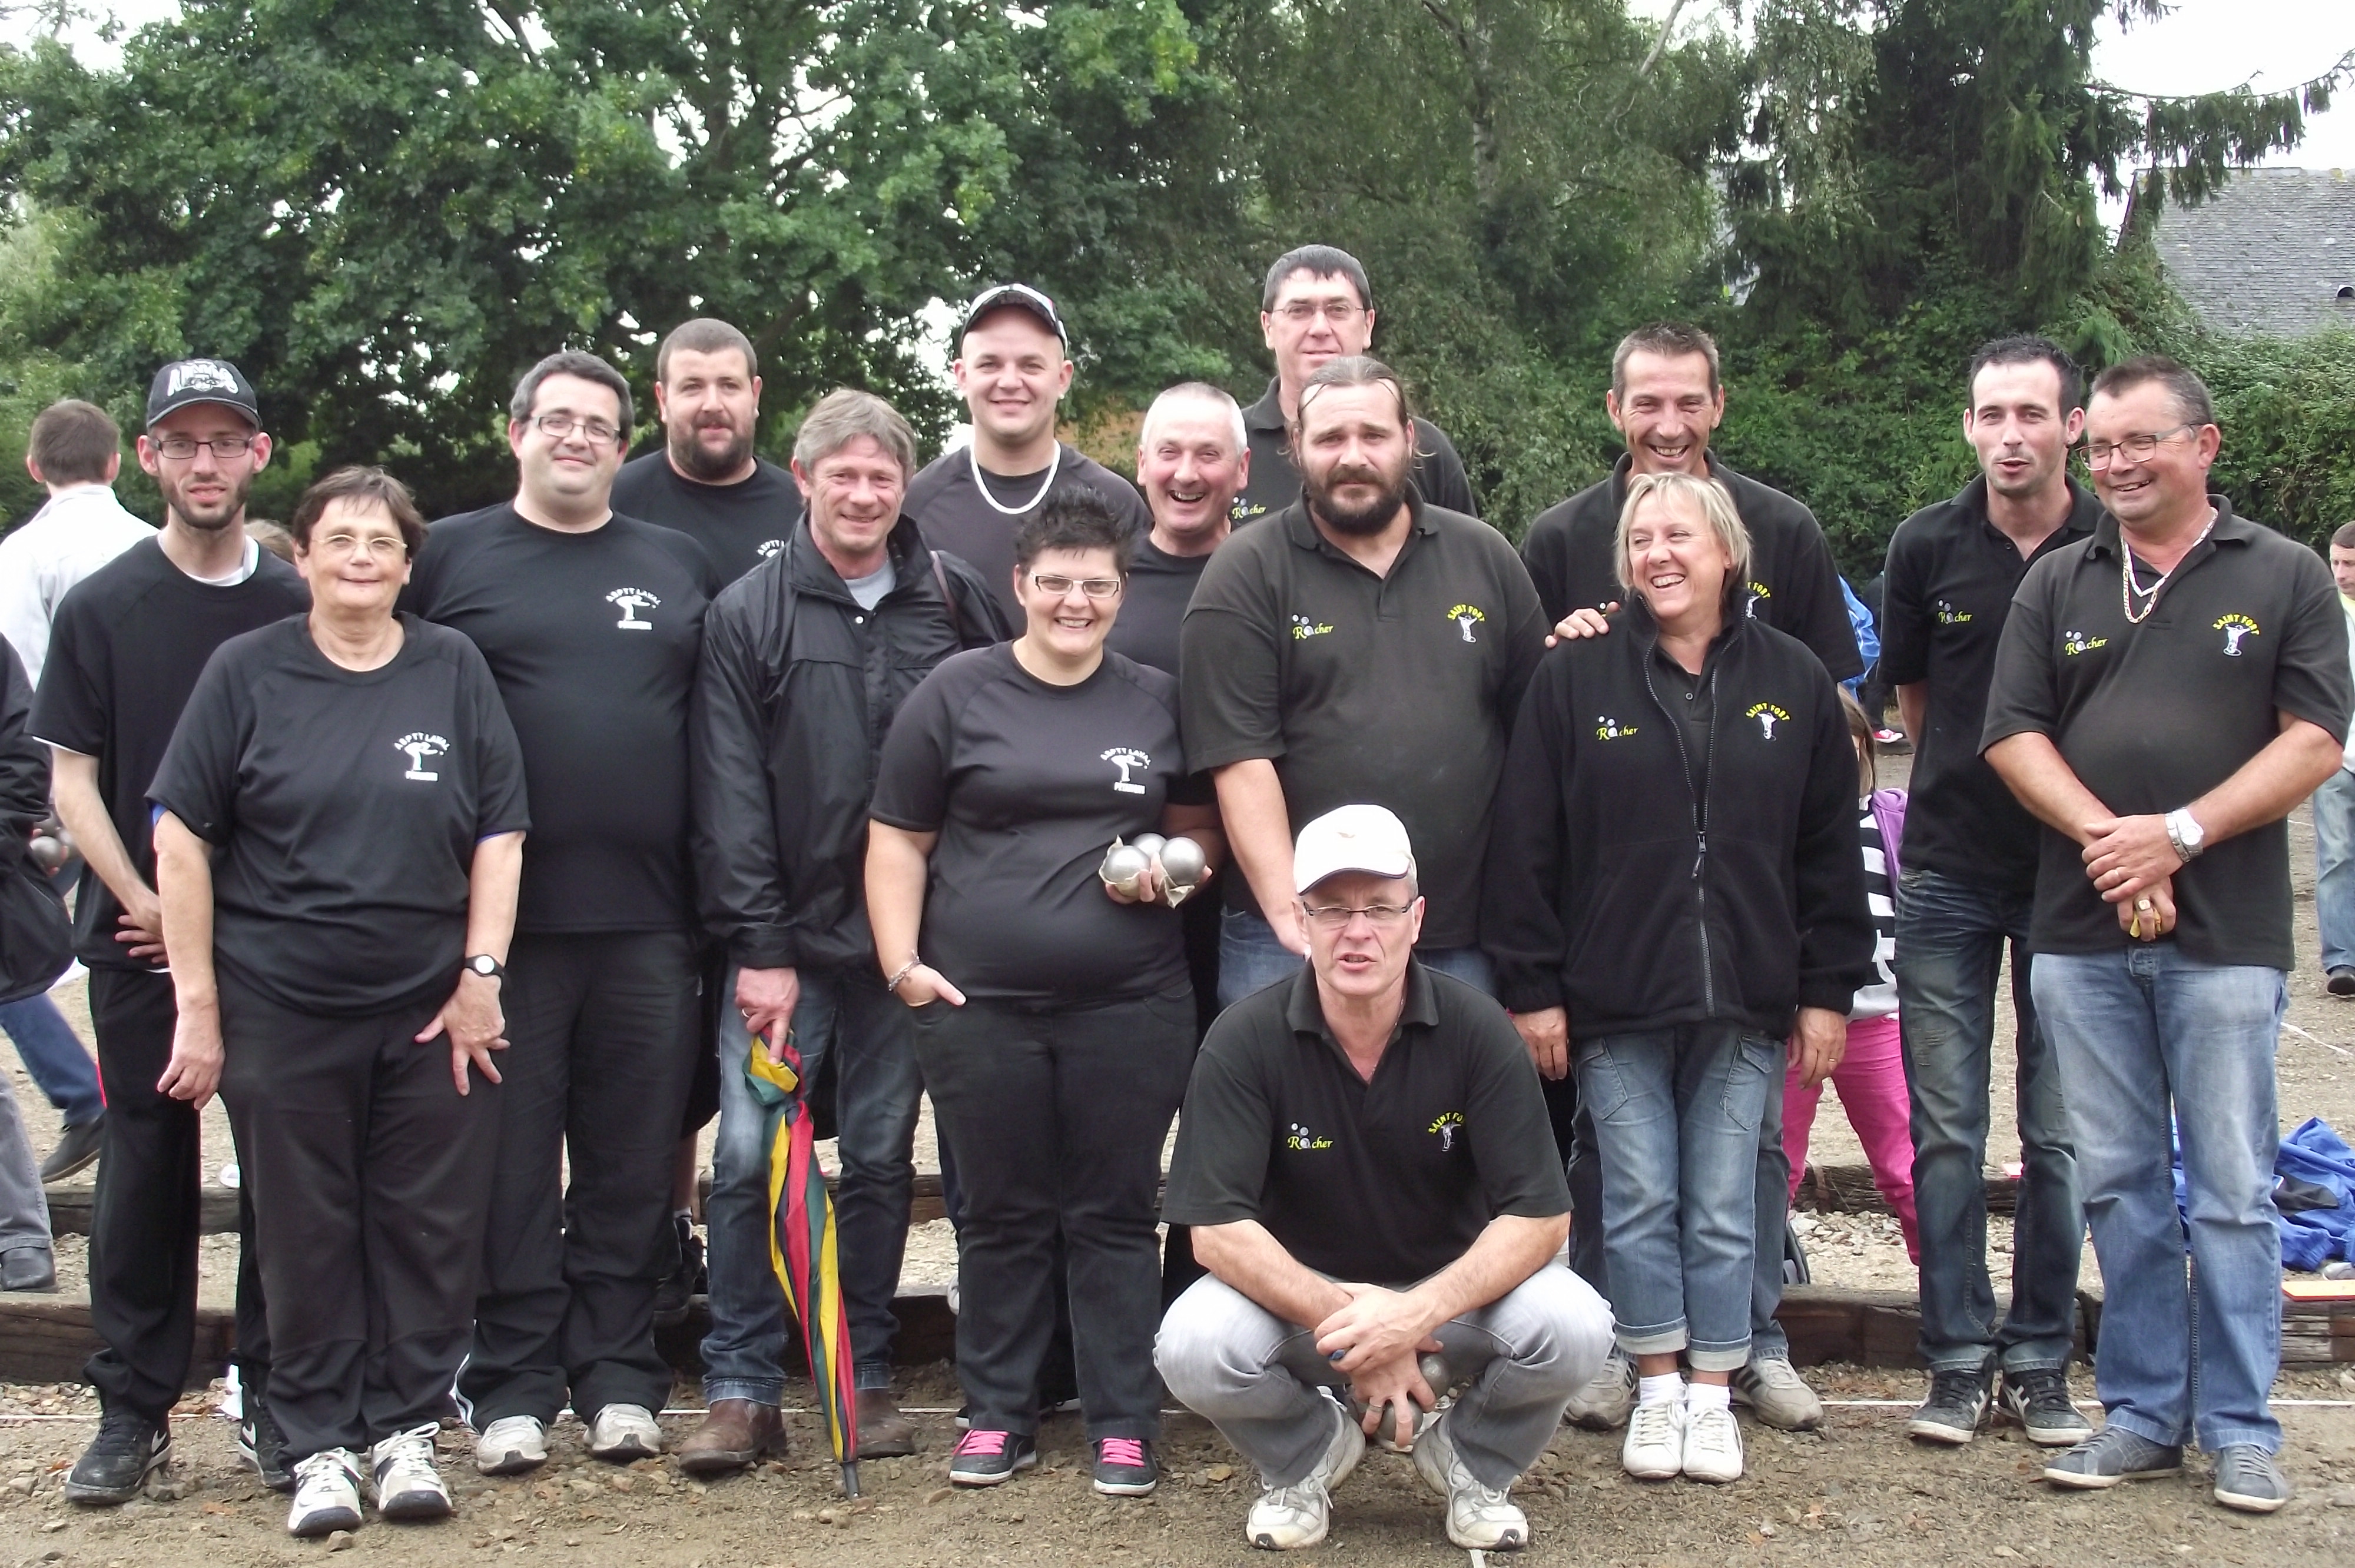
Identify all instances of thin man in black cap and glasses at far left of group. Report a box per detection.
[33,360,311,1504]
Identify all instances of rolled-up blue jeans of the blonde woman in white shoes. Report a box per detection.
[1575,1024,1783,1373]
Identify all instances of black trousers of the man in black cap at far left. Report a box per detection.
[82,970,271,1422]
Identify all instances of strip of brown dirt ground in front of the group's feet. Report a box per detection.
[0,1368,2355,1568]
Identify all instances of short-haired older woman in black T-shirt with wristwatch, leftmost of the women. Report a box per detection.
[148,469,528,1535]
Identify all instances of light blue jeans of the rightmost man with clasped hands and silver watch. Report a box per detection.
[2035,942,2289,1453]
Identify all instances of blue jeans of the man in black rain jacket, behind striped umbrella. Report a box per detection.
[704,965,923,1406]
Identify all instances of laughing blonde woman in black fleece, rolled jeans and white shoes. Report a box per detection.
[1481,473,1875,1481]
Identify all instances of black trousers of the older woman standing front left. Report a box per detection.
[219,972,499,1464]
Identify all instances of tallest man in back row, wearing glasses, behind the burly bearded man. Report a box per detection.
[1234,245,1479,523]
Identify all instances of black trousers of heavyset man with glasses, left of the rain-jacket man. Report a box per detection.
[457,932,699,1431]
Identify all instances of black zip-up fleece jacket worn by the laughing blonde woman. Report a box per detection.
[1481,600,1875,1041]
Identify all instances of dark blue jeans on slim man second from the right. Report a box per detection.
[1896,871,2084,1373]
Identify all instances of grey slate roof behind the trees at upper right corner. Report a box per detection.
[2152,170,2355,337]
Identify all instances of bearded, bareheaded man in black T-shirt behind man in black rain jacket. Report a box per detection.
[612,315,801,1323]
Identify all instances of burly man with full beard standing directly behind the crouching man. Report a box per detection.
[1180,356,1545,1005]
